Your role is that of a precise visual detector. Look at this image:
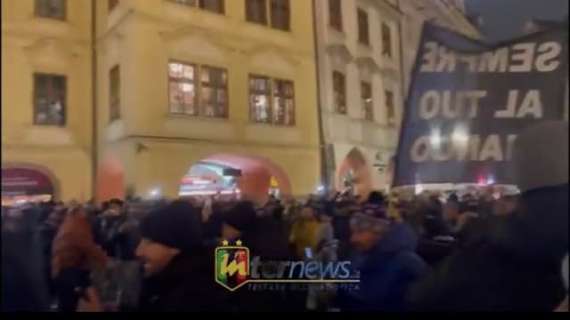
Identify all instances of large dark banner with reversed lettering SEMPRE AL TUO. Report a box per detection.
[394,24,568,186]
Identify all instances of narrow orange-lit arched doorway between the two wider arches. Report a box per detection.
[96,156,125,202]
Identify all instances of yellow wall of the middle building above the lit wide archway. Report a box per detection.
[97,0,319,201]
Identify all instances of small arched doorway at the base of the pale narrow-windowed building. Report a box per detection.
[336,148,372,197]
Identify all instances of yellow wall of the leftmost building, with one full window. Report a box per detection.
[2,0,92,200]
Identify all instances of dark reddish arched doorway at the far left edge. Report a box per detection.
[2,165,58,206]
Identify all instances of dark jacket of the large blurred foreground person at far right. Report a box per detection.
[411,186,568,312]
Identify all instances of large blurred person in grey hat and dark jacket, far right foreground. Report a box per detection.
[410,122,569,311]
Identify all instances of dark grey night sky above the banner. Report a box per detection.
[465,0,569,42]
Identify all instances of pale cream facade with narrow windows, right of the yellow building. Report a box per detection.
[316,0,403,192]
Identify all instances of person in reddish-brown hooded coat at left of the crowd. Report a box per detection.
[52,207,107,312]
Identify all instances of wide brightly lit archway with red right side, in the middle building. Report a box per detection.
[179,154,292,202]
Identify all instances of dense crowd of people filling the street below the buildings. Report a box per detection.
[2,123,568,312]
